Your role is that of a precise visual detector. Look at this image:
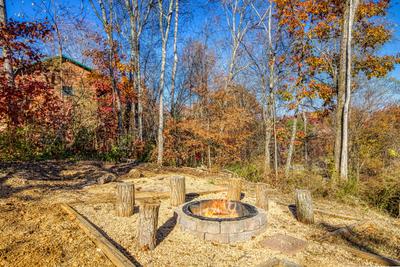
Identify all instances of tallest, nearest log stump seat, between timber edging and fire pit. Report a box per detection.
[138,201,160,250]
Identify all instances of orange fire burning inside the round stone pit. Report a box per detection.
[201,200,239,218]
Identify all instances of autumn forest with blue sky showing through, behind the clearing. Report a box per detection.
[0,0,400,216]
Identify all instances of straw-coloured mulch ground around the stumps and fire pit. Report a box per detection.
[0,161,400,266]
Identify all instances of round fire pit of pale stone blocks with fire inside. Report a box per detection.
[176,199,267,243]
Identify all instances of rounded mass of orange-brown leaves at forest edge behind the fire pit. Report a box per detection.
[164,86,259,165]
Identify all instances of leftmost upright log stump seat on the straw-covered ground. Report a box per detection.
[115,183,135,217]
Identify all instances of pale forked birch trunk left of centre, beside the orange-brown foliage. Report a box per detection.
[157,0,174,166]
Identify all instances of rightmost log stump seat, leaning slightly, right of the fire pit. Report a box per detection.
[295,190,314,224]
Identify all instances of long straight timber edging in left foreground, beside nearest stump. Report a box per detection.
[60,203,135,267]
